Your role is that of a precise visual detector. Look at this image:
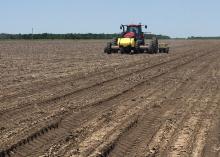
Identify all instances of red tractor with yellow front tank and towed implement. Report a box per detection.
[104,24,169,54]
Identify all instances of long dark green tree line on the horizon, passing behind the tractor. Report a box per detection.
[0,33,170,40]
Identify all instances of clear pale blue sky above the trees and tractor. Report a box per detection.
[0,0,220,37]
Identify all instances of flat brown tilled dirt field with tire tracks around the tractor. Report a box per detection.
[0,40,220,157]
